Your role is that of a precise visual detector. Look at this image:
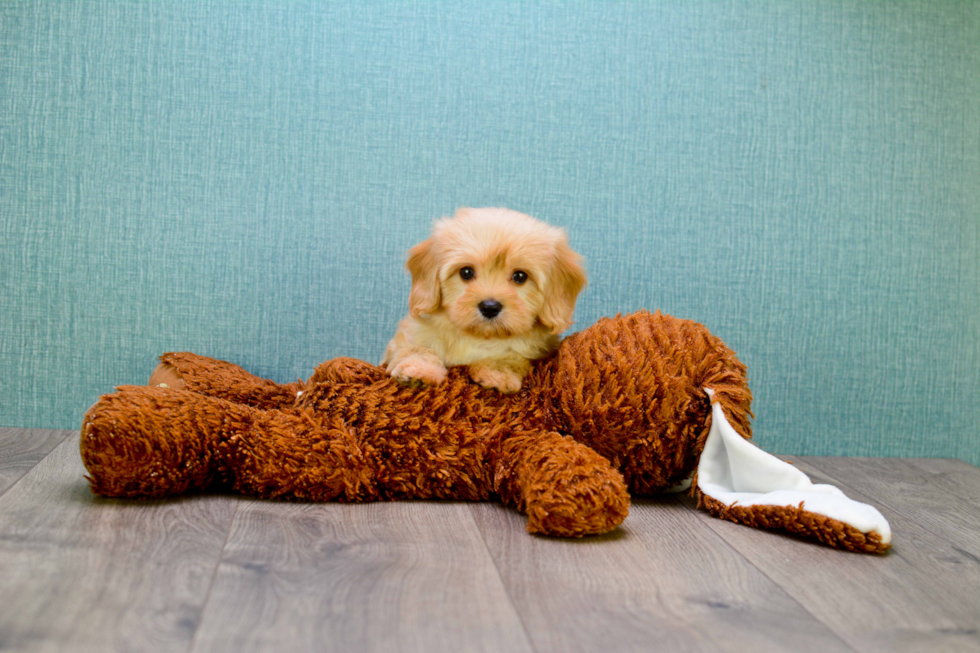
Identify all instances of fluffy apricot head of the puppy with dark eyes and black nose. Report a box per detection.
[408,208,586,338]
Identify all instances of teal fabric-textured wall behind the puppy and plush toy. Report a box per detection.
[0,0,980,463]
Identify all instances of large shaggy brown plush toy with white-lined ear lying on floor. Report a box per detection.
[81,312,890,552]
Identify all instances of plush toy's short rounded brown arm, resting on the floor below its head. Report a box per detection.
[491,432,630,537]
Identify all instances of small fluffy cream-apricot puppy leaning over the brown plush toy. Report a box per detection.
[382,208,586,393]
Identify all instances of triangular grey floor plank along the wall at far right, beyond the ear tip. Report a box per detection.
[801,457,980,562]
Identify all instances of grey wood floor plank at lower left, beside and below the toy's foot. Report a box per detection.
[0,436,235,652]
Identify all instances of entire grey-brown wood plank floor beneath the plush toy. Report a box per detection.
[0,429,980,653]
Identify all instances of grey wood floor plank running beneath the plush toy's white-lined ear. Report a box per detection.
[684,457,980,652]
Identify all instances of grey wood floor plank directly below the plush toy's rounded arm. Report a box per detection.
[471,497,852,653]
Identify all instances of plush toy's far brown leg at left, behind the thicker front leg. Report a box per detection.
[155,352,303,409]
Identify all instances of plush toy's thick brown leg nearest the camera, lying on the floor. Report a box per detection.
[81,386,381,501]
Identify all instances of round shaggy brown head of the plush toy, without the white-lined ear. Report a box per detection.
[546,312,752,494]
